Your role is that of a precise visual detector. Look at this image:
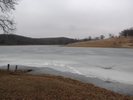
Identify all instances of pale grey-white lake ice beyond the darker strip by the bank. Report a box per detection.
[0,46,133,95]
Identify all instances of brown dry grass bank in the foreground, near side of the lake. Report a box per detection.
[0,69,133,100]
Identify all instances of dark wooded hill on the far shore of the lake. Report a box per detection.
[0,34,75,45]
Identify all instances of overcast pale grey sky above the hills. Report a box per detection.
[12,0,133,39]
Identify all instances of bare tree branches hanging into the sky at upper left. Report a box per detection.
[0,0,19,34]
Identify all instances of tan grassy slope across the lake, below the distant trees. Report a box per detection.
[66,36,133,48]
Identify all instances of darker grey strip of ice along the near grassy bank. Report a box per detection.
[0,65,133,96]
